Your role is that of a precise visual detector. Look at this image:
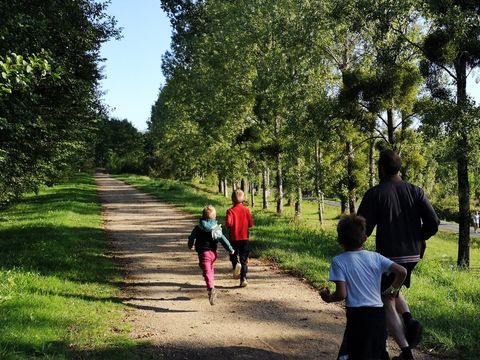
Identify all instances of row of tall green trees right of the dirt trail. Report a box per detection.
[146,0,480,267]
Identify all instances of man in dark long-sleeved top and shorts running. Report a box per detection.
[358,150,440,359]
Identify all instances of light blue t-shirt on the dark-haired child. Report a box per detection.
[329,250,393,307]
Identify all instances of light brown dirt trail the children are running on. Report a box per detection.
[96,174,431,360]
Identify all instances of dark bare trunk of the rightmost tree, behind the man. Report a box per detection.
[455,56,470,268]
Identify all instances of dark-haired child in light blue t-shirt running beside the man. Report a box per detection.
[320,215,407,360]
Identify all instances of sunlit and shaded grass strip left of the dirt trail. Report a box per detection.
[0,174,160,359]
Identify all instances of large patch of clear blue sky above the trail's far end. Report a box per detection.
[101,0,171,130]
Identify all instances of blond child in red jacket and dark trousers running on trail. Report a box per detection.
[225,189,253,287]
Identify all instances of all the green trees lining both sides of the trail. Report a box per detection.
[0,0,480,267]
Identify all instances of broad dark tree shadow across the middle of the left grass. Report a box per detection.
[0,225,118,283]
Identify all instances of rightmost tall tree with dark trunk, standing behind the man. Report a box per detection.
[414,0,480,268]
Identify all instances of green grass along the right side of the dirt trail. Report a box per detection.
[118,175,480,360]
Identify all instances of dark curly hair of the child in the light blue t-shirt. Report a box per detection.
[337,214,367,250]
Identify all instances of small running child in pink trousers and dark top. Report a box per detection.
[188,205,235,305]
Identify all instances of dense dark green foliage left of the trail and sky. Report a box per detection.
[0,0,118,206]
